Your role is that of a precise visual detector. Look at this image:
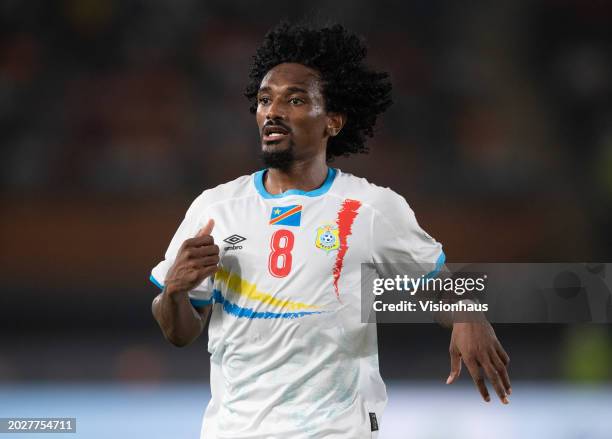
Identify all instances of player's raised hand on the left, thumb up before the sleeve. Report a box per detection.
[165,219,219,295]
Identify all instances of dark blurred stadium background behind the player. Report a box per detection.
[0,0,612,439]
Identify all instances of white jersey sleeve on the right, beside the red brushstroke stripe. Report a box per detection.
[372,189,446,277]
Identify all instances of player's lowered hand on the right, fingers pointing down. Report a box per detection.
[446,322,512,404]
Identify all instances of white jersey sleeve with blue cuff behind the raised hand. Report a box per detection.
[149,196,214,307]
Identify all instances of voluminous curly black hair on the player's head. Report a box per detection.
[245,21,391,160]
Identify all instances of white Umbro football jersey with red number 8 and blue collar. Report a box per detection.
[151,168,444,439]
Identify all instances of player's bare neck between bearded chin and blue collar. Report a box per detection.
[263,155,328,194]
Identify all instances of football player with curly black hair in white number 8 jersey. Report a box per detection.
[152,23,510,439]
